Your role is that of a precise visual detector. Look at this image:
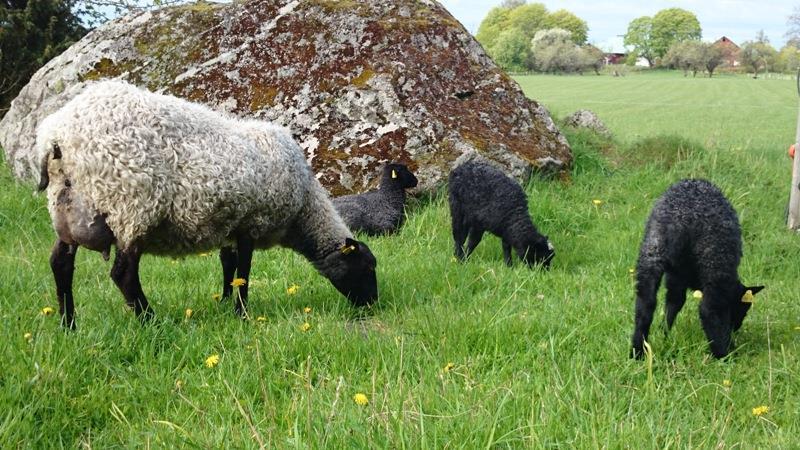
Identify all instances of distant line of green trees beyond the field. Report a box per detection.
[476,0,800,76]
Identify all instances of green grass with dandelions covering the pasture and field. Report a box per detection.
[0,74,800,449]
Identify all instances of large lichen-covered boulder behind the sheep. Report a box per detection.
[0,0,571,195]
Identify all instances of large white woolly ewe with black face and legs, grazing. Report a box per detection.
[35,81,377,327]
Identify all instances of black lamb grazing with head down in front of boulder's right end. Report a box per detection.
[448,160,555,268]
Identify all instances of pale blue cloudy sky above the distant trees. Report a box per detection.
[440,0,800,52]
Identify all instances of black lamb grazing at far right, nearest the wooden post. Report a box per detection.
[631,180,764,358]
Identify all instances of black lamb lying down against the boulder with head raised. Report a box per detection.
[333,163,417,236]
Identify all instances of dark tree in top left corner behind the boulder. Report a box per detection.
[0,0,87,117]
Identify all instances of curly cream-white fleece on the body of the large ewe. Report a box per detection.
[36,81,352,261]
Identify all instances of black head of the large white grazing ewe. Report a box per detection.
[317,238,378,306]
